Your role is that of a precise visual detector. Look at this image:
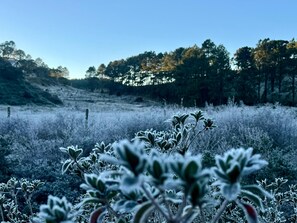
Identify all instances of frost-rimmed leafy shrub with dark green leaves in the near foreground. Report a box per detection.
[2,109,296,223]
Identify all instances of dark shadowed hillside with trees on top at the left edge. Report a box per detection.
[0,41,68,105]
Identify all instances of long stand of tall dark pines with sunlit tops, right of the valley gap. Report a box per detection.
[86,39,297,105]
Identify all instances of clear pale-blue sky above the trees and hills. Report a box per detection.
[0,0,297,78]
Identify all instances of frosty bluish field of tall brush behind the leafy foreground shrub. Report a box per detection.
[0,103,297,221]
